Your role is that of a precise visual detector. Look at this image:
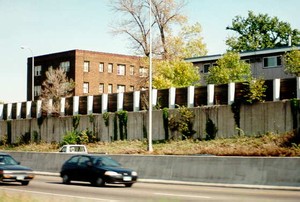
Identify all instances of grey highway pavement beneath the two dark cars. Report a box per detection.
[0,175,300,202]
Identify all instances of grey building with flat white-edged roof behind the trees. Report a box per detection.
[185,46,300,85]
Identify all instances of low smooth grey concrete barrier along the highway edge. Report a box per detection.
[7,152,300,186]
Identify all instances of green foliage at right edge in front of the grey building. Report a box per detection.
[284,50,300,76]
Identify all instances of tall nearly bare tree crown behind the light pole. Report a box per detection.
[112,0,186,59]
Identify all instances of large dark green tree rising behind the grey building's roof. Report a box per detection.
[226,11,300,52]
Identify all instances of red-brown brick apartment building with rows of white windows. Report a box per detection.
[27,50,148,100]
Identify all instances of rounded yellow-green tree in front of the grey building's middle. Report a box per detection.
[207,52,251,84]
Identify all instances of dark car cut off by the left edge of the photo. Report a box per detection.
[0,153,34,185]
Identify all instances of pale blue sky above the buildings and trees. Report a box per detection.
[0,0,300,103]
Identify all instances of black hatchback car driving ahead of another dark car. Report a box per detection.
[60,155,138,187]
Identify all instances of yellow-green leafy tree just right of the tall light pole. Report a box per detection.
[152,60,200,89]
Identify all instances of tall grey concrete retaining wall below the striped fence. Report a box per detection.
[0,101,293,143]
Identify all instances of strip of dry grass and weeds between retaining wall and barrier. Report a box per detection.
[0,132,300,157]
